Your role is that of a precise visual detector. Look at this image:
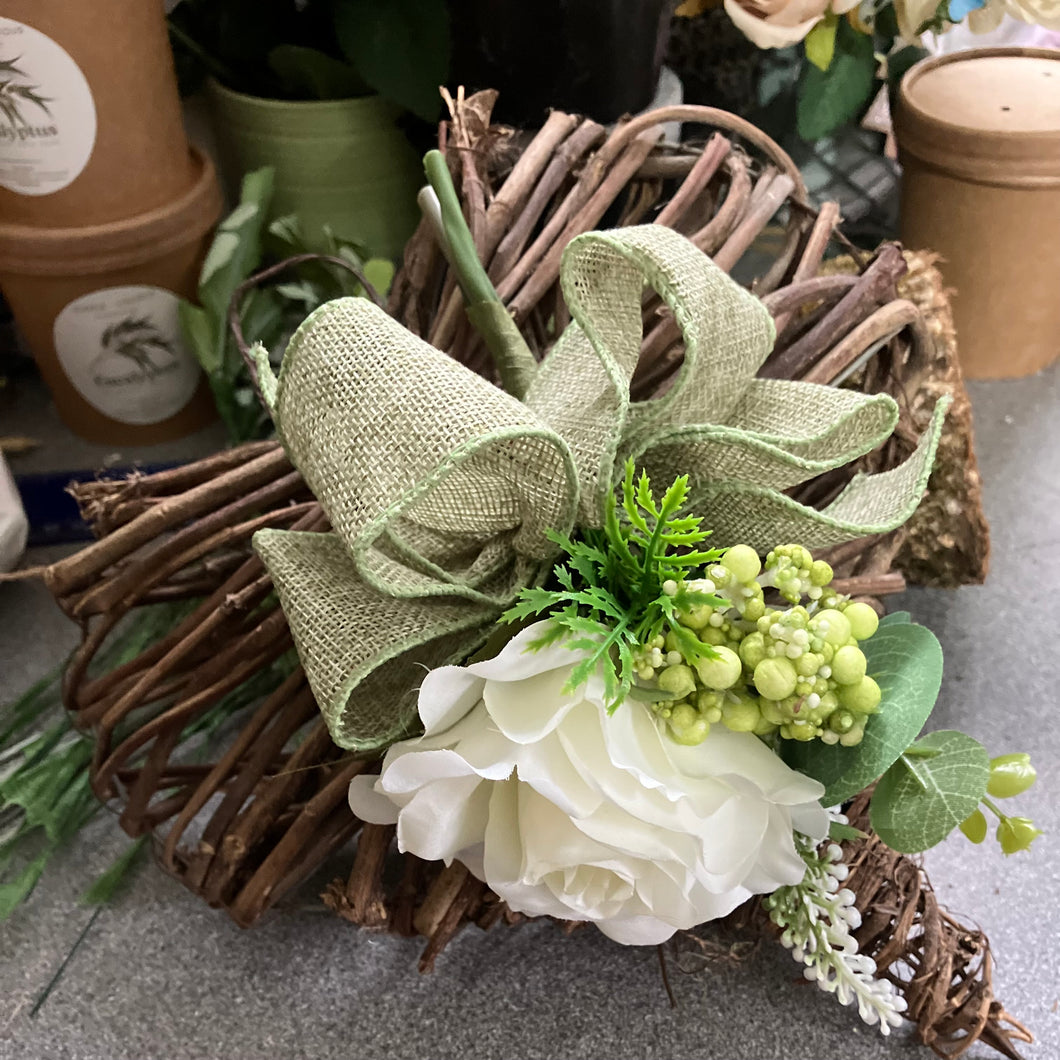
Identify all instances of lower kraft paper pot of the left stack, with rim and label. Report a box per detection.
[0,152,222,444]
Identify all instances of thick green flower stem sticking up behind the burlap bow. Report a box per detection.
[423,151,537,401]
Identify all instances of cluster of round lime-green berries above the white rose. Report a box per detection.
[634,545,881,746]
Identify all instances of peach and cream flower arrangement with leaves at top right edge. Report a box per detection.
[676,0,1060,140]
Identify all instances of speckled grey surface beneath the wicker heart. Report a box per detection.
[0,365,1060,1060]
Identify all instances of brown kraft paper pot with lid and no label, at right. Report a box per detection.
[895,48,1060,378]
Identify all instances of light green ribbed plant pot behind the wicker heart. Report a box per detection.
[211,83,424,260]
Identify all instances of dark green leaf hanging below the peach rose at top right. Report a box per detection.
[796,18,876,140]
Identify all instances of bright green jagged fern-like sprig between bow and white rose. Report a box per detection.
[501,460,723,712]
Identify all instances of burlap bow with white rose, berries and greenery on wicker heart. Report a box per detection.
[245,208,1039,1034]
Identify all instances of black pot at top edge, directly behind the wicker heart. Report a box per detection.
[451,0,673,126]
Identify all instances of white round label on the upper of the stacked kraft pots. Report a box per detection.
[0,18,95,195]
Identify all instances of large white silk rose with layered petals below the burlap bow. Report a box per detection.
[350,622,828,944]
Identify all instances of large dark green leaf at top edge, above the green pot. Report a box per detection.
[334,0,449,122]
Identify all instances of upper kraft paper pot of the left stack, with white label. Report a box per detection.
[0,0,196,228]
